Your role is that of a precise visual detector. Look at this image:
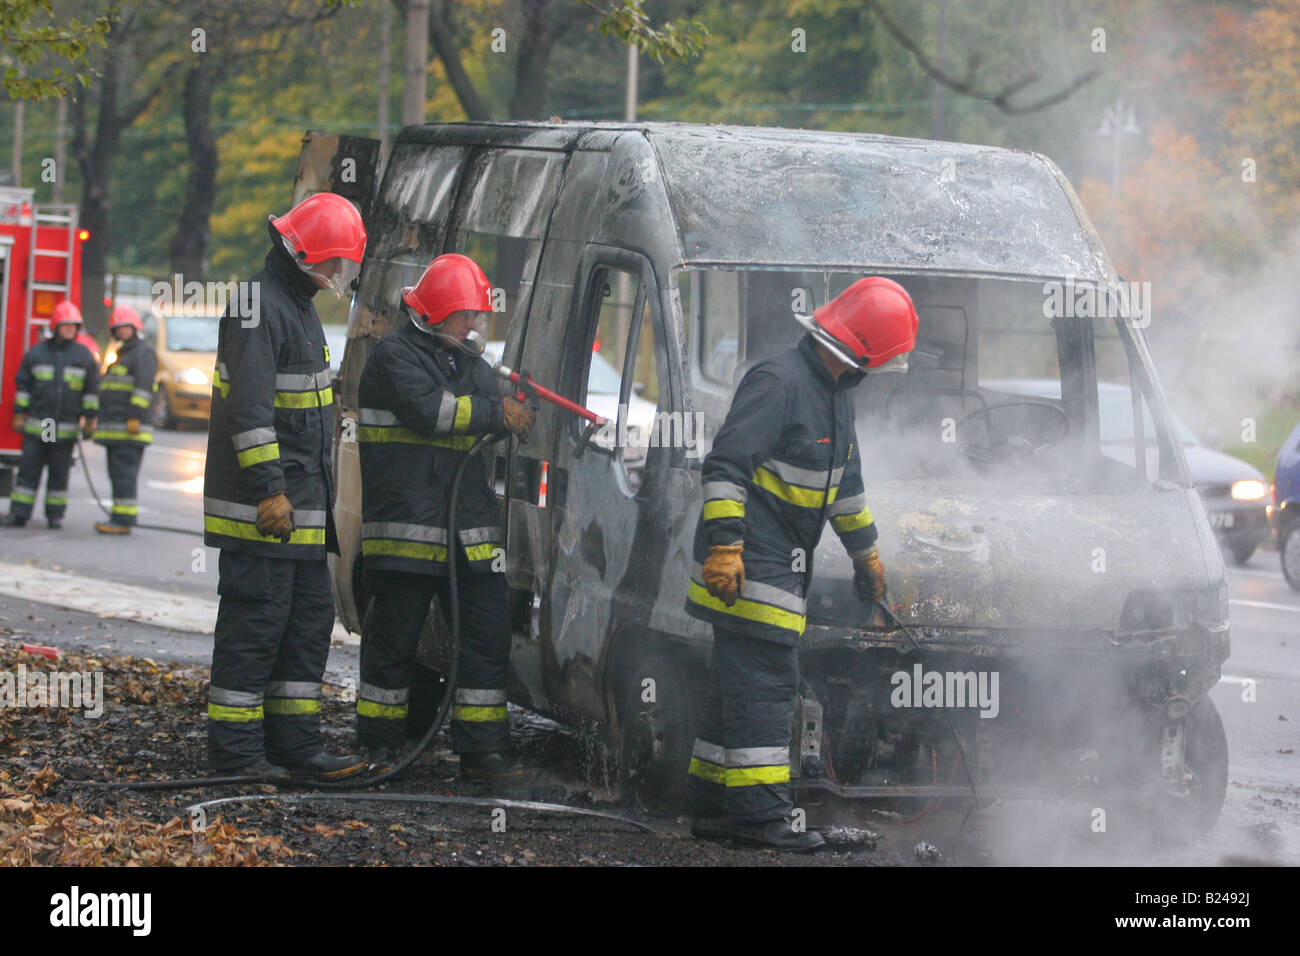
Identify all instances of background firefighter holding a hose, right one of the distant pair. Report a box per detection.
[95,306,159,535]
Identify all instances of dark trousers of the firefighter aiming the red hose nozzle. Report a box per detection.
[356,553,510,753]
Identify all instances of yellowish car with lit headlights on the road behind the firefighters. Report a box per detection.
[140,311,221,428]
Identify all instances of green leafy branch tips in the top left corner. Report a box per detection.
[0,0,117,101]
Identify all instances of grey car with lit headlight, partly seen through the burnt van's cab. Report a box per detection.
[980,380,1269,564]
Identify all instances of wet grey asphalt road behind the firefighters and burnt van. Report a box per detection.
[0,431,1300,864]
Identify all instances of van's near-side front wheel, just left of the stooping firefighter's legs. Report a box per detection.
[619,650,697,817]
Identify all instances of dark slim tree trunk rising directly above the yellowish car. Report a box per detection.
[172,56,218,281]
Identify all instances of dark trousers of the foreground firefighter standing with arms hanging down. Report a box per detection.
[208,551,334,770]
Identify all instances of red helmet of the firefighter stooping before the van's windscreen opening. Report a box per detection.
[798,276,919,372]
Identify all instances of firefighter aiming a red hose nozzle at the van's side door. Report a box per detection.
[356,254,533,786]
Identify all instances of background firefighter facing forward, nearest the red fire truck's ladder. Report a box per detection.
[4,302,99,531]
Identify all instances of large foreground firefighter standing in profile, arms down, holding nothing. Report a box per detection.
[203,193,365,780]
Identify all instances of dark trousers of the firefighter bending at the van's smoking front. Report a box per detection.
[686,627,798,823]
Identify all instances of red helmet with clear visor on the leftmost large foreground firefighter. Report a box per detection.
[270,193,365,297]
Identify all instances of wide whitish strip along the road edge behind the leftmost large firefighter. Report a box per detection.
[0,562,361,644]
